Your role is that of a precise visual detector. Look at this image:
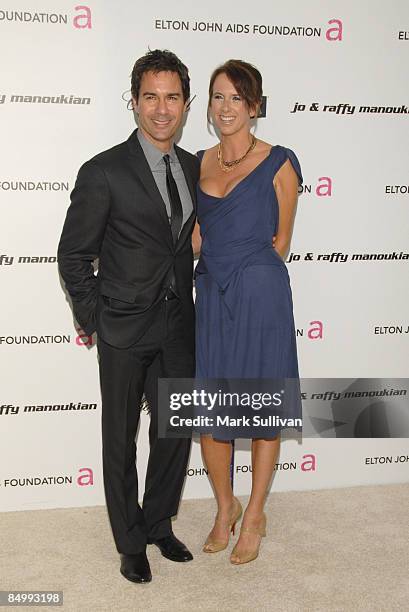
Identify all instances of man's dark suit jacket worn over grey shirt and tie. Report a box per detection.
[58,130,199,348]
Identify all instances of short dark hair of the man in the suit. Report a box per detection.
[131,49,190,102]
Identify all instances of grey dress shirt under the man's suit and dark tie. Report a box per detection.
[137,129,193,227]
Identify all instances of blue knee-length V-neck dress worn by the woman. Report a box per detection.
[195,145,302,437]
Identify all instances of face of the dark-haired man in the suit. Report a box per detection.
[133,71,187,153]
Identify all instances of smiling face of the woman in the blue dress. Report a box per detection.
[210,73,253,136]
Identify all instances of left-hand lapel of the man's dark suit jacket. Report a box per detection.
[128,130,173,246]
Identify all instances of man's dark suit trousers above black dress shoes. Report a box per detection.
[98,298,194,554]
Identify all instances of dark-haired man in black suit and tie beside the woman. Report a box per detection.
[58,50,199,582]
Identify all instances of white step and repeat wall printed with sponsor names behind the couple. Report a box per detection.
[0,0,409,511]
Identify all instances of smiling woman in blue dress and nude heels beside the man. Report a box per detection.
[193,60,302,564]
